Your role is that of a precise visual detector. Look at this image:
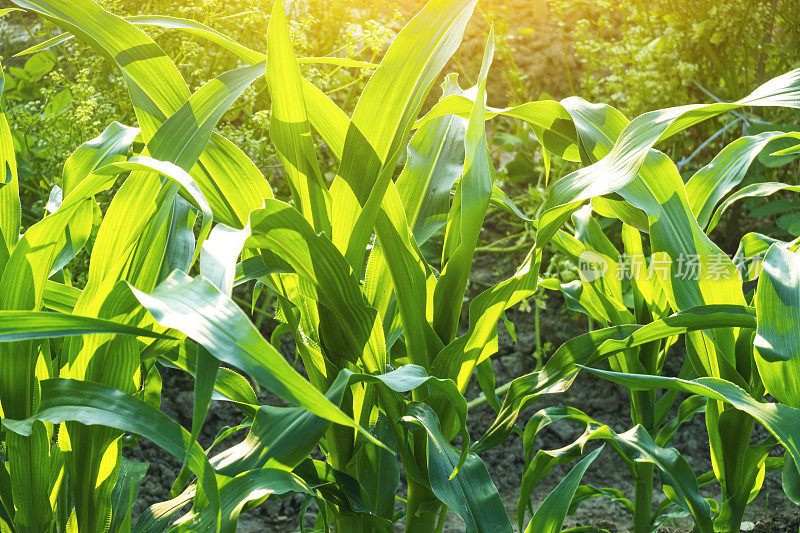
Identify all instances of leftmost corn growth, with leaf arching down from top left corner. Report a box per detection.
[0,3,296,531]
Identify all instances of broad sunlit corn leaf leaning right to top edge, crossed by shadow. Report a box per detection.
[331,0,476,274]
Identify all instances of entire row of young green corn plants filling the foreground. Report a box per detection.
[0,0,800,533]
